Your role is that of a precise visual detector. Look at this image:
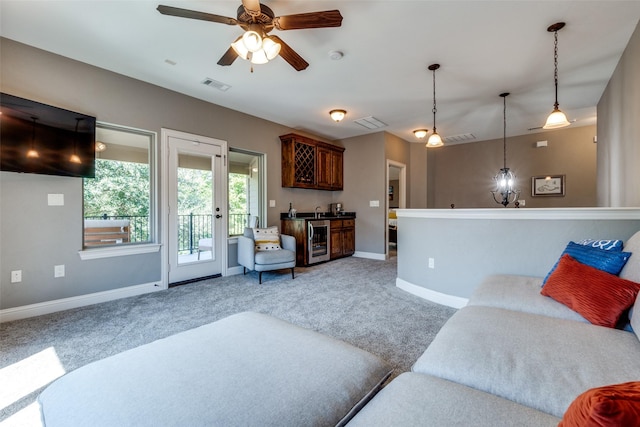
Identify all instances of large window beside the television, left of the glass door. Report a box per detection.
[83,123,156,249]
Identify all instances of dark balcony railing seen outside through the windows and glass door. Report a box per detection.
[84,214,249,254]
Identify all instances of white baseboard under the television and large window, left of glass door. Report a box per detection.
[0,282,162,323]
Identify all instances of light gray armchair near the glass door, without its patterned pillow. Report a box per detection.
[238,228,296,284]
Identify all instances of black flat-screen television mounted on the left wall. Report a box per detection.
[0,93,96,178]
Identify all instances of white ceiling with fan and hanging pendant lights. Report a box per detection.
[0,0,640,142]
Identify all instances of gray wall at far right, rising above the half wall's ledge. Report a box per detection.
[597,23,640,207]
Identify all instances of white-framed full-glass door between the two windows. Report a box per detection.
[162,129,227,286]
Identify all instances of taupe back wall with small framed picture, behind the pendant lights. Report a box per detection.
[427,125,597,209]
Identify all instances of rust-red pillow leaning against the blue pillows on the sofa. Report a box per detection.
[540,254,640,328]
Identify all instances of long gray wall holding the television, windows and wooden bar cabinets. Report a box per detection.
[0,38,400,309]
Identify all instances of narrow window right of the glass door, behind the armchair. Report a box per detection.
[228,148,266,236]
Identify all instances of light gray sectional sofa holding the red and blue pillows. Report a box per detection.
[350,232,640,426]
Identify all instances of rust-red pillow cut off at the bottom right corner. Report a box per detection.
[558,381,640,427]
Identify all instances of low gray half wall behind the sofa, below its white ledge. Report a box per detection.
[398,209,640,298]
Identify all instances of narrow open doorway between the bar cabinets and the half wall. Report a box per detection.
[385,159,407,259]
